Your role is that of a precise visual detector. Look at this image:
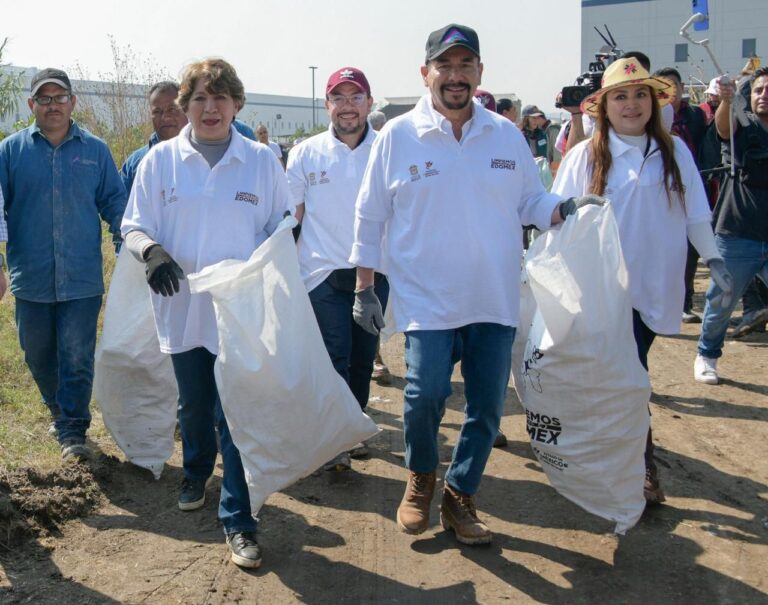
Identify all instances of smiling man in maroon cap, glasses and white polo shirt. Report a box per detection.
[287,67,389,471]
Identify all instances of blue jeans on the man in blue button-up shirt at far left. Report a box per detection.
[16,296,101,443]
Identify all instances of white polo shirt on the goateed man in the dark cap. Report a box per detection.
[350,95,560,331]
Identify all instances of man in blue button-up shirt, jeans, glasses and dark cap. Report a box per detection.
[0,68,126,460]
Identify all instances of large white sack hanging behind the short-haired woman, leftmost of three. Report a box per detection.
[93,248,179,479]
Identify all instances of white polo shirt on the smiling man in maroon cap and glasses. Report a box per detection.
[287,124,376,292]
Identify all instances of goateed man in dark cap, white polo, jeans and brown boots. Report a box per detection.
[350,24,575,544]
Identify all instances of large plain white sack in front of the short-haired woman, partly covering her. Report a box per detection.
[188,217,378,514]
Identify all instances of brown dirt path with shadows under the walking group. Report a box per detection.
[0,276,768,605]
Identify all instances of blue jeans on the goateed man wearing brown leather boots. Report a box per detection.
[403,323,515,495]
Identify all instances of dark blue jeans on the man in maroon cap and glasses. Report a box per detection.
[309,278,389,409]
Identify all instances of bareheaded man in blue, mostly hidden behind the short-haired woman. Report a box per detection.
[120,80,187,195]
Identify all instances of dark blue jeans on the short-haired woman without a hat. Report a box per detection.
[171,347,256,534]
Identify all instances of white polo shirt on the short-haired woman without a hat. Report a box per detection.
[122,124,290,354]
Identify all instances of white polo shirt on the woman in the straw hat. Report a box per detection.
[552,129,712,334]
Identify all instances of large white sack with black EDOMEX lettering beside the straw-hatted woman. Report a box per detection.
[515,205,651,533]
